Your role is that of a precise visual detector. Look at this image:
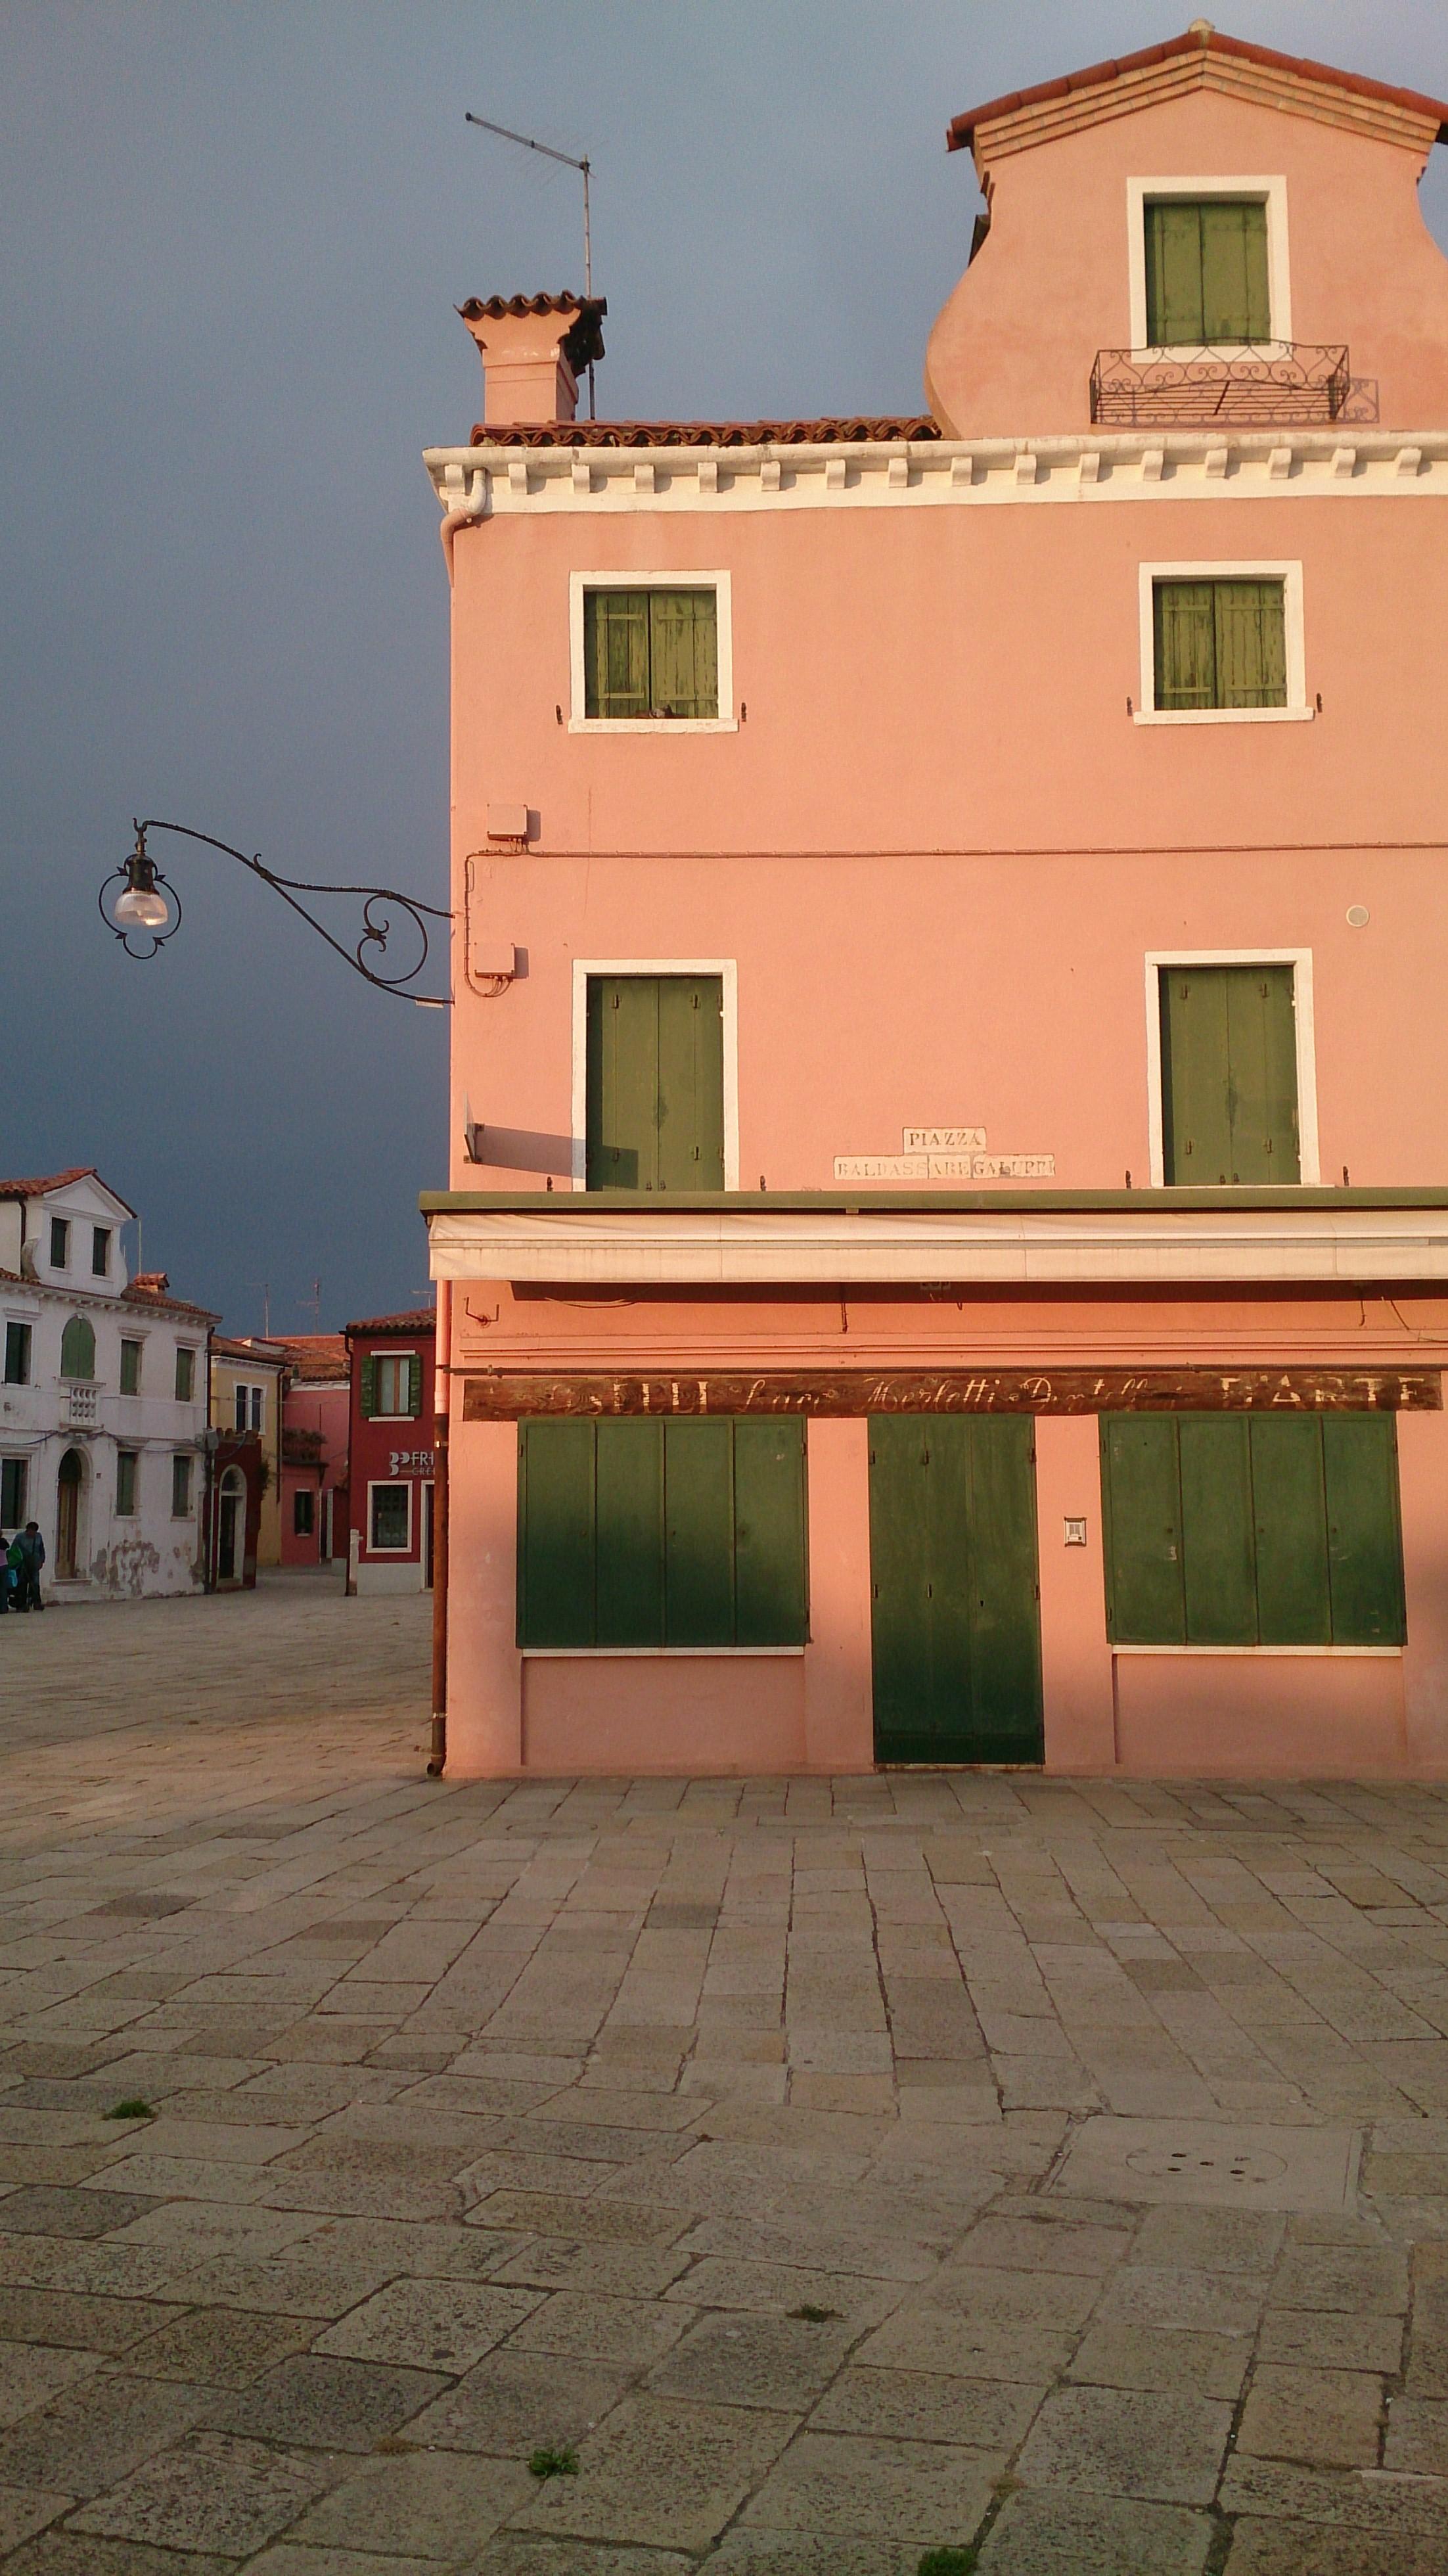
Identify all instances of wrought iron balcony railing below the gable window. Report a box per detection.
[1090,340,1378,430]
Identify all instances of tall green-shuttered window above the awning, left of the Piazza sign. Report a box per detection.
[587,974,724,1190]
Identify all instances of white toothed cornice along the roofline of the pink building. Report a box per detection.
[422,425,1448,518]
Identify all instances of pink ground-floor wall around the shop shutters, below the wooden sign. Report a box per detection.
[438,1414,1448,1780]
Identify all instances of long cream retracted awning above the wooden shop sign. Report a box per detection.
[428,1201,1448,1288]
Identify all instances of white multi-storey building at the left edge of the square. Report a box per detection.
[0,1172,216,1602]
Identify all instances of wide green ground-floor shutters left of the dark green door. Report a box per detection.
[518,1414,809,1646]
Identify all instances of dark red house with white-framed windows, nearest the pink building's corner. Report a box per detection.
[343,1306,436,1592]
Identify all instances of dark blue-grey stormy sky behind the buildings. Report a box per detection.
[0,0,1448,1332]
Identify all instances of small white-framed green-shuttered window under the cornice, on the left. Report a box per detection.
[572,572,735,731]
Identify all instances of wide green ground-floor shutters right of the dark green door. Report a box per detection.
[1100,1412,1407,1646]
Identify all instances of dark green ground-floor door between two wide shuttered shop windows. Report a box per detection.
[871,1414,1043,1762]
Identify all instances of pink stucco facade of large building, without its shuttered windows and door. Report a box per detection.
[425,44,1448,1778]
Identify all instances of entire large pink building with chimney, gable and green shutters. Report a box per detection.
[412,26,1448,1778]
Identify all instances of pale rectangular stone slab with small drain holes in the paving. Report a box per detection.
[1054,2115,1358,2210]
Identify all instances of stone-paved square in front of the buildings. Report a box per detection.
[0,1579,1448,2576]
